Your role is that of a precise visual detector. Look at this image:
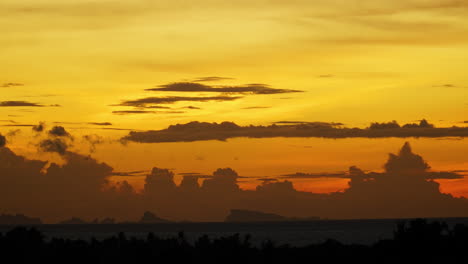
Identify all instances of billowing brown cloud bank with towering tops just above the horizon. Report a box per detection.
[0,141,468,221]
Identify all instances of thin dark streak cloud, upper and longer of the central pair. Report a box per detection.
[146,82,303,94]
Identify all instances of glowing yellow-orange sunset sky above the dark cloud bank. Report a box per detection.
[0,0,468,221]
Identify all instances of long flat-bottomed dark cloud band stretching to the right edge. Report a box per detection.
[122,121,468,143]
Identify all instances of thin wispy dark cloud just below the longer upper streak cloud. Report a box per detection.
[118,96,242,108]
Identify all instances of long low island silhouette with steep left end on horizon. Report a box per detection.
[224,209,320,222]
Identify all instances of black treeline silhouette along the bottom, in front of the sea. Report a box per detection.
[0,219,468,263]
